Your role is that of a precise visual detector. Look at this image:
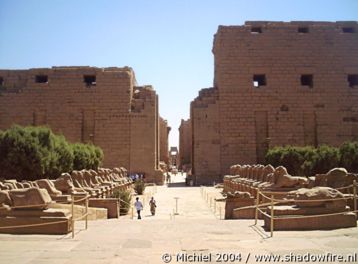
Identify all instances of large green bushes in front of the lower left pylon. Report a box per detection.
[0,125,103,181]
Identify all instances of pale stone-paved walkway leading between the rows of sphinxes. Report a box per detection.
[0,173,358,264]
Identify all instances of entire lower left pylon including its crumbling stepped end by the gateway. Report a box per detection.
[0,67,168,183]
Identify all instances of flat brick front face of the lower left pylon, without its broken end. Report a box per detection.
[0,68,132,167]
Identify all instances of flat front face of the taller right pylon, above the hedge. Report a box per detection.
[213,23,358,174]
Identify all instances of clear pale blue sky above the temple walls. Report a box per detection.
[0,0,358,148]
